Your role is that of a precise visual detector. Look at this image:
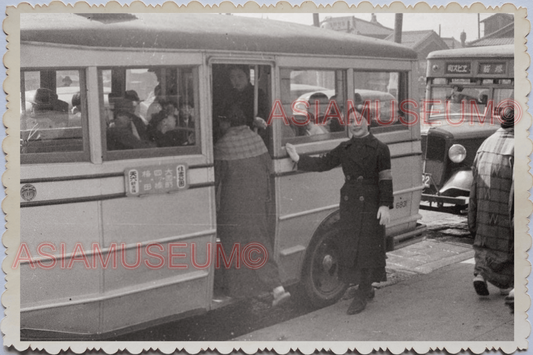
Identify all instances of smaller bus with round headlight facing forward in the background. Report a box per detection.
[421,45,519,213]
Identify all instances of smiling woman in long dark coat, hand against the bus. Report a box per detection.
[286,110,394,314]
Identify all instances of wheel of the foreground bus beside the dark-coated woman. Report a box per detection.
[302,228,348,307]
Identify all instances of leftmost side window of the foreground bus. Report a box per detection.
[20,70,85,159]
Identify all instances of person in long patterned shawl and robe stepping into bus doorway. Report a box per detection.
[214,105,290,306]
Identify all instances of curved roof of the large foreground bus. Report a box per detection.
[20,13,417,59]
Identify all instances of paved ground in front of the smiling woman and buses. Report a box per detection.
[236,248,514,341]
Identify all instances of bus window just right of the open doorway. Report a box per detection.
[281,69,346,143]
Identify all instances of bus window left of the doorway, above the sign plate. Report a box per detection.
[100,67,198,155]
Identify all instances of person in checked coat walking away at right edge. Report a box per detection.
[468,109,514,296]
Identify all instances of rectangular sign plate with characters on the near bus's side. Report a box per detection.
[124,164,189,196]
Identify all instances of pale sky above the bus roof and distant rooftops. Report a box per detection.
[235,13,492,42]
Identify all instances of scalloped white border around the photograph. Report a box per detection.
[1,1,533,354]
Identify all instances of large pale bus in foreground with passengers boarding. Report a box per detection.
[17,13,424,339]
